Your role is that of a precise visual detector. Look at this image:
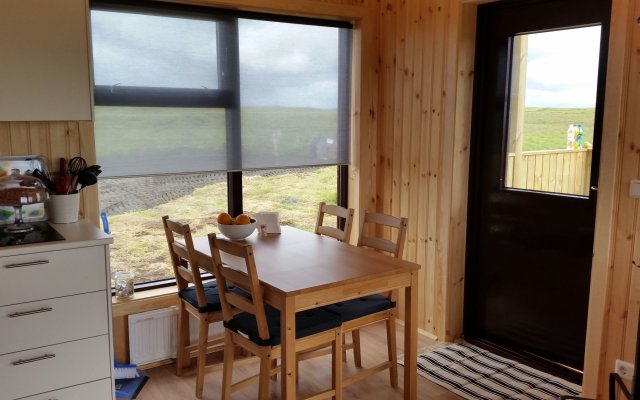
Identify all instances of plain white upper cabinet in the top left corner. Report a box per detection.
[0,0,92,121]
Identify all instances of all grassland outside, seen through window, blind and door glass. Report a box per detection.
[96,107,594,282]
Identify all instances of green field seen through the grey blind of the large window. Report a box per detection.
[95,106,337,157]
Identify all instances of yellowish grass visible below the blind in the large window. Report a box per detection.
[109,167,337,282]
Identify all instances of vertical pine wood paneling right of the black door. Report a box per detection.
[583,0,640,398]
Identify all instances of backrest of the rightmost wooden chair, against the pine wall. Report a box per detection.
[358,212,407,258]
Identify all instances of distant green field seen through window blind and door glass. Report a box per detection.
[95,106,594,157]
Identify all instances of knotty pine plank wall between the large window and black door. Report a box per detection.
[370,0,475,340]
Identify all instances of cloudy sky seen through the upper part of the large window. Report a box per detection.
[91,11,338,109]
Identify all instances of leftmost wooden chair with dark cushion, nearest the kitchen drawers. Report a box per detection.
[162,215,224,398]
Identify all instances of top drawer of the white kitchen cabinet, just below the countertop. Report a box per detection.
[0,246,107,306]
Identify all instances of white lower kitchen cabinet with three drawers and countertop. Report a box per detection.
[0,221,115,400]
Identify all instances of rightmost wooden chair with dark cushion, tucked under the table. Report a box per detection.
[323,212,407,388]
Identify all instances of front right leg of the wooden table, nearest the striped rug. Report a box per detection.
[404,271,418,400]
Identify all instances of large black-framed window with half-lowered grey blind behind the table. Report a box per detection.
[91,0,351,288]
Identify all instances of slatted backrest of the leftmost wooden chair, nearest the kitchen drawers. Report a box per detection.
[162,215,213,307]
